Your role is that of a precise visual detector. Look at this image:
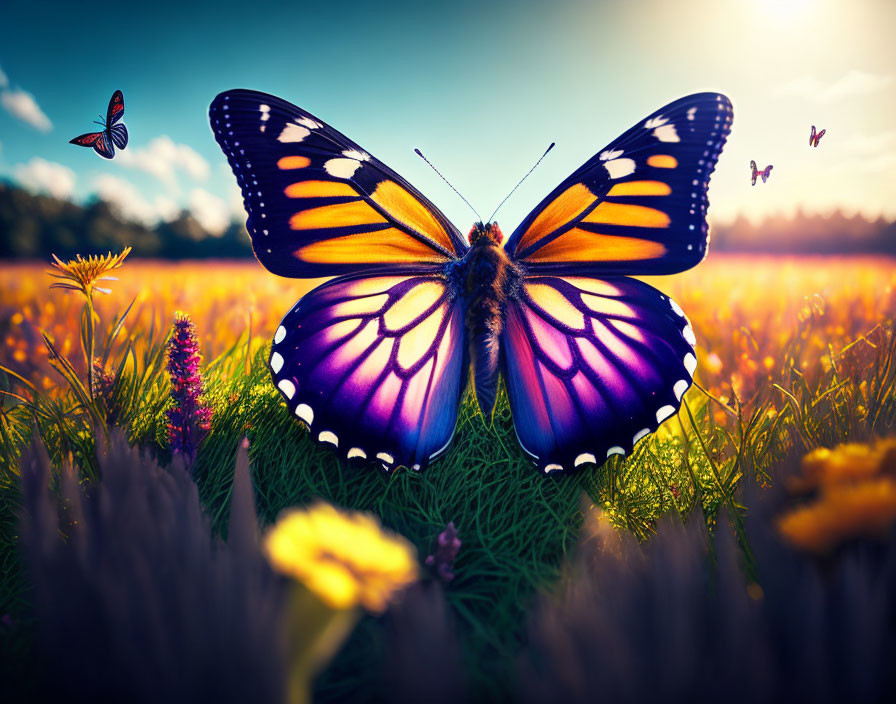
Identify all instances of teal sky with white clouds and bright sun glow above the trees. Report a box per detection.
[0,0,896,236]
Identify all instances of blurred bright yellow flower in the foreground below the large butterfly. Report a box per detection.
[264,502,418,612]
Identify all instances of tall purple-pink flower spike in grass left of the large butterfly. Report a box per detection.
[167,312,212,463]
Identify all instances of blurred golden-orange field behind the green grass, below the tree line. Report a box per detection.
[0,255,896,408]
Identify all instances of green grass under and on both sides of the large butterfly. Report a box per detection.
[0,308,896,699]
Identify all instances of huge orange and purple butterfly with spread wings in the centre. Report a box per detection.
[210,90,732,472]
